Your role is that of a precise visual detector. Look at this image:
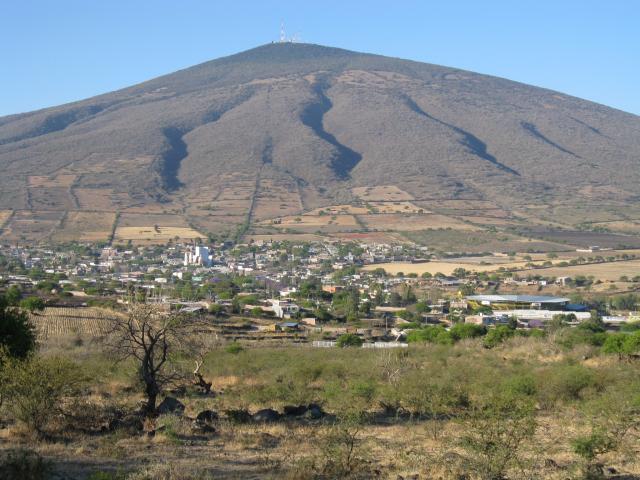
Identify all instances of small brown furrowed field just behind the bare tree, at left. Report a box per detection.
[29,307,122,342]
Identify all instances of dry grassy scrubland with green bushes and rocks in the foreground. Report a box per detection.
[0,332,640,480]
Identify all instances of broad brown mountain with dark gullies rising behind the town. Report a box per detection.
[0,43,640,239]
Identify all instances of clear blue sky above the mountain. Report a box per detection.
[0,0,640,115]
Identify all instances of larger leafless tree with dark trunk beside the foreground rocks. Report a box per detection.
[104,303,194,415]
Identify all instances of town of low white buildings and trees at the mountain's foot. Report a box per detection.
[0,241,640,348]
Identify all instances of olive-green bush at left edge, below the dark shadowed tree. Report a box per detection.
[0,356,86,436]
